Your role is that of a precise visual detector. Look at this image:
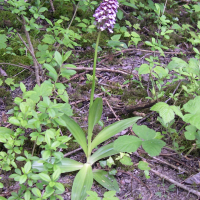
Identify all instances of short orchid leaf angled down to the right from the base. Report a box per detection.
[93,170,119,192]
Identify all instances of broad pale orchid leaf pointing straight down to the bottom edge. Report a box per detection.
[71,163,93,200]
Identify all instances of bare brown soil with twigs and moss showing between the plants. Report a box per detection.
[0,50,200,200]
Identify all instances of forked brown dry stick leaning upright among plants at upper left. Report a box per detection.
[20,16,40,85]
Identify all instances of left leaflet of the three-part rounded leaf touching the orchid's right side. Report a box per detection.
[114,135,142,153]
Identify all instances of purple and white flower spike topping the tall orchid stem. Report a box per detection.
[93,0,119,33]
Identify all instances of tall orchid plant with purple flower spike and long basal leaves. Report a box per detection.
[32,0,140,200]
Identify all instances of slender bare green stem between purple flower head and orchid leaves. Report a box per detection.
[90,31,101,107]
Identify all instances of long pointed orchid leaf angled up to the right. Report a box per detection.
[92,117,141,149]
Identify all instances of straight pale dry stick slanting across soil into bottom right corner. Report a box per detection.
[150,169,200,197]
